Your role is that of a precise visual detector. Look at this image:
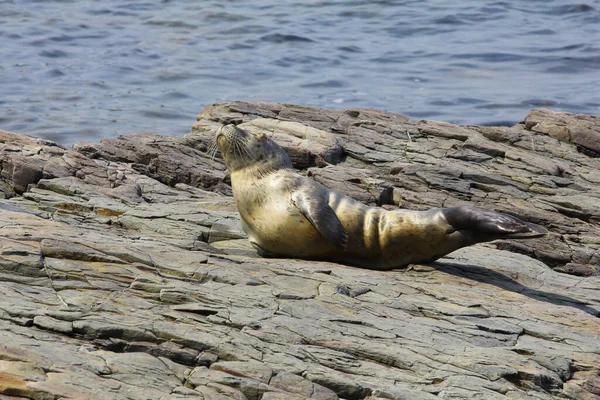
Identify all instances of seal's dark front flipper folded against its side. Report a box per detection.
[292,191,348,249]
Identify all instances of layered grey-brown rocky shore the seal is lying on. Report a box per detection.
[0,102,600,400]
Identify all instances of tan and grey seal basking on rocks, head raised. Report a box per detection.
[215,125,547,270]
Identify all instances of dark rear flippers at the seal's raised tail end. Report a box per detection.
[442,206,548,241]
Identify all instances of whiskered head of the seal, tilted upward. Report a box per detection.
[215,124,292,173]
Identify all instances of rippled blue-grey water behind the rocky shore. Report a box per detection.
[0,0,600,145]
